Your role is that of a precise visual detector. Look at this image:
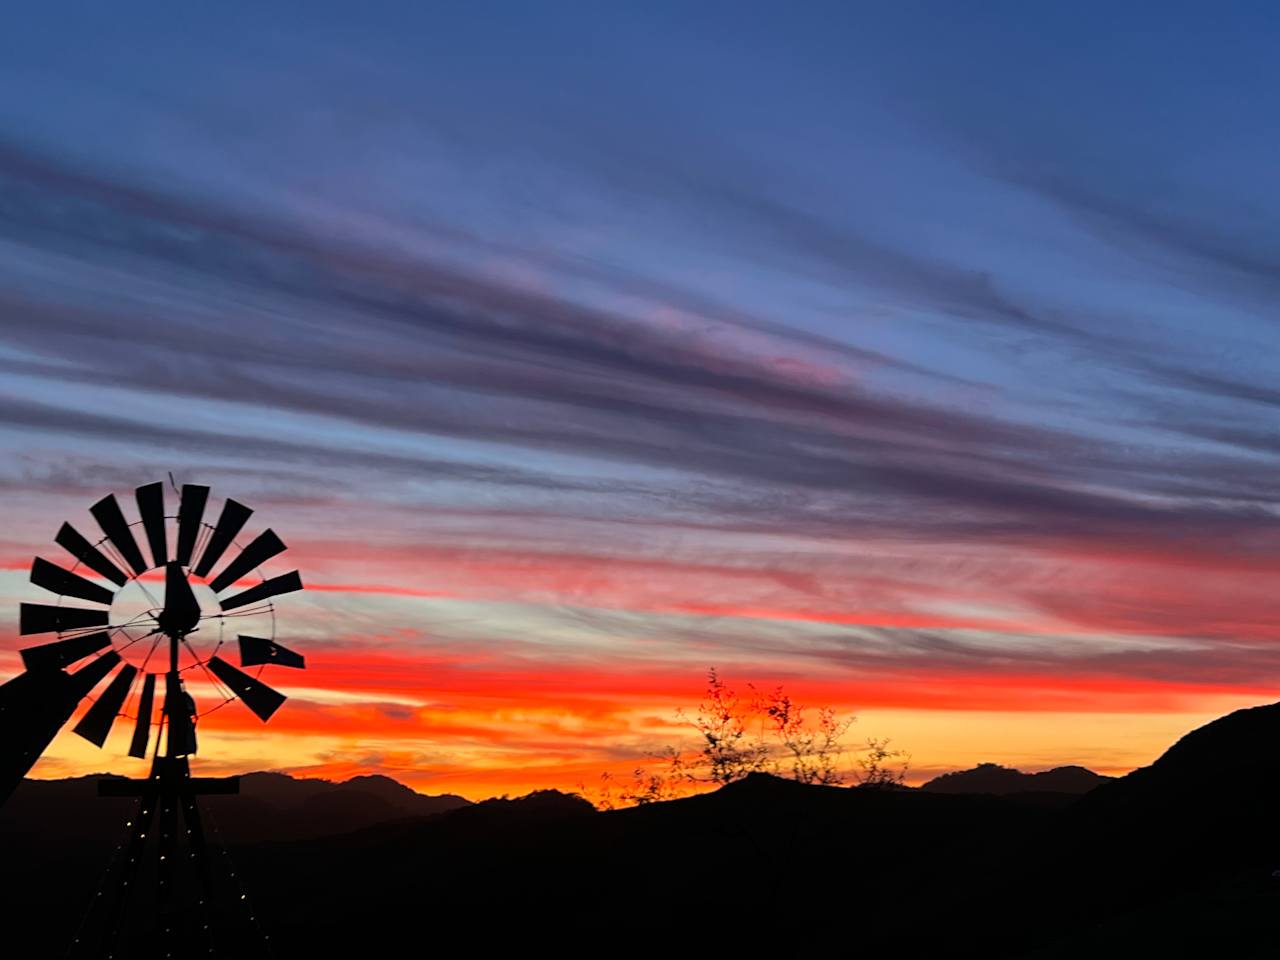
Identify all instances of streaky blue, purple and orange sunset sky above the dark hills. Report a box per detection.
[0,0,1280,799]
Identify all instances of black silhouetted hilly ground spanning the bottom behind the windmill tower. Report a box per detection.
[0,704,1280,957]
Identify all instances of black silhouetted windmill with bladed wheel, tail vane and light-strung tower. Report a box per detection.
[0,476,306,956]
